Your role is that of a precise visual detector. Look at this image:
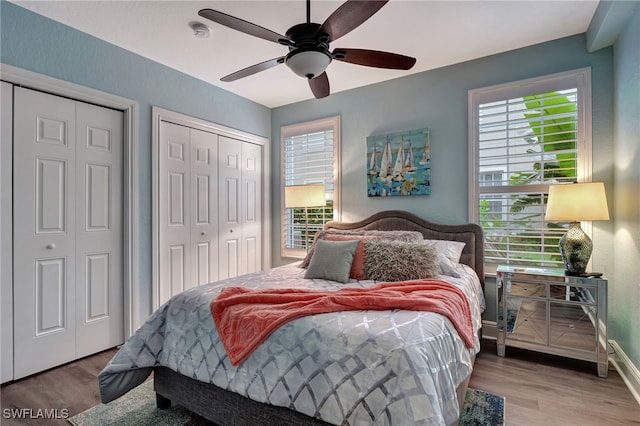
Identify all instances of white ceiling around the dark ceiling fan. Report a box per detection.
[13,0,598,107]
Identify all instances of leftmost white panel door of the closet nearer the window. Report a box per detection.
[158,121,192,305]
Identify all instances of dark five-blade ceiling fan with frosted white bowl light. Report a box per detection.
[198,0,416,98]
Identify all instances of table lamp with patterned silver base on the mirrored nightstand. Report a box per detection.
[545,182,609,275]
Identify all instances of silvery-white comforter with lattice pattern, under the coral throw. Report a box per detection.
[99,264,484,426]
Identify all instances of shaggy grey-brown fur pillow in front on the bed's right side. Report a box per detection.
[364,240,440,281]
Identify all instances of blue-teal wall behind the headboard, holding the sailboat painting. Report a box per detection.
[271,35,613,272]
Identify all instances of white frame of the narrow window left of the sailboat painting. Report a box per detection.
[280,115,342,259]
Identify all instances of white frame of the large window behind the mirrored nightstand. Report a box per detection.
[468,67,592,273]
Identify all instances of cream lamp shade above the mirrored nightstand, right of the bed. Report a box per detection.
[545,182,609,222]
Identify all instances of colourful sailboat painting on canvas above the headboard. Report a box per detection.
[367,129,431,197]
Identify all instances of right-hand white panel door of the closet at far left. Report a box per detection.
[76,103,124,358]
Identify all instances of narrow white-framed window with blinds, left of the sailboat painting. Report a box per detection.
[280,116,340,257]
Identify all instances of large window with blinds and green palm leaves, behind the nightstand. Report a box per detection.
[469,69,591,268]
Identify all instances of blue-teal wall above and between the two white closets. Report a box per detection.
[0,1,271,319]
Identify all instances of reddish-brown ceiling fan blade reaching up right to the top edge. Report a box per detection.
[318,0,389,42]
